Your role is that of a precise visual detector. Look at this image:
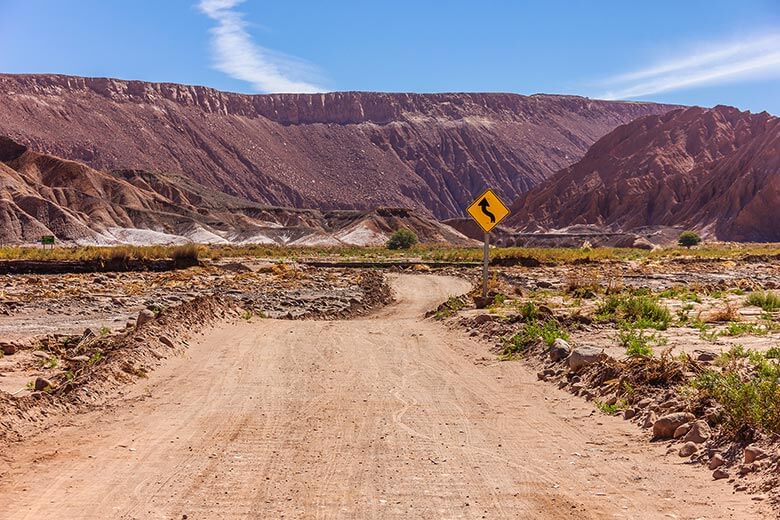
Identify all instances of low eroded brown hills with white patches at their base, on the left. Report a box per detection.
[0,137,470,245]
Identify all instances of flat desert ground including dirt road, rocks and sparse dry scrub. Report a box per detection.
[0,249,780,519]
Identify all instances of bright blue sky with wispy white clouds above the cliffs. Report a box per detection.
[0,0,780,115]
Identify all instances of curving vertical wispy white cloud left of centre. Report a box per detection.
[198,0,325,92]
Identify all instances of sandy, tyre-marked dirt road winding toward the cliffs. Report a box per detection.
[0,275,765,519]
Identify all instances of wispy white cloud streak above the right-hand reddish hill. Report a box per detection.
[601,33,780,99]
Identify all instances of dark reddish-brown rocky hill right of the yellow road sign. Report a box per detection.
[509,106,780,241]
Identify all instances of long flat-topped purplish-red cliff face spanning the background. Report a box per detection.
[0,75,674,218]
